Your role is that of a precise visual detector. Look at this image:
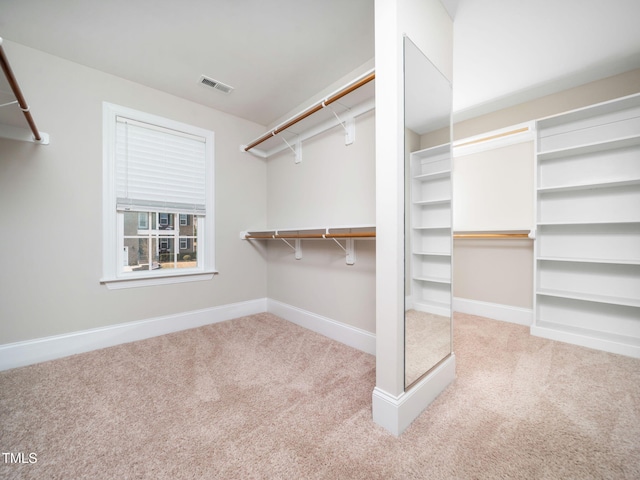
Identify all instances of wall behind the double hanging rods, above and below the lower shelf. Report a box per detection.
[266,108,376,333]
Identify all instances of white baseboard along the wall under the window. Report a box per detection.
[0,298,267,371]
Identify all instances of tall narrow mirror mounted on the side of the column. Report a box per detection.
[404,37,452,389]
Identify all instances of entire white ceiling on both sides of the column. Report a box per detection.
[0,0,640,125]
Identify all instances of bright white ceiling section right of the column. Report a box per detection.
[453,0,640,120]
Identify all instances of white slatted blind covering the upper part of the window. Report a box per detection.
[115,116,206,215]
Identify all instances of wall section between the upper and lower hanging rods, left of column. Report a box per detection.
[266,111,376,231]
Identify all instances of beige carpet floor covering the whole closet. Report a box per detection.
[0,314,640,480]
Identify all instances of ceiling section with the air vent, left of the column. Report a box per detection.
[0,0,374,125]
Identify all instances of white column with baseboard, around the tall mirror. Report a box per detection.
[372,0,455,435]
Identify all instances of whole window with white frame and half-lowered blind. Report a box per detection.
[102,103,215,288]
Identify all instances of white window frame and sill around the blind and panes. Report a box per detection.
[100,102,217,289]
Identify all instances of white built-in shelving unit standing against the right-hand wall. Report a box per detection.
[532,94,640,357]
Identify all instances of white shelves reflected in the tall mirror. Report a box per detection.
[407,144,452,317]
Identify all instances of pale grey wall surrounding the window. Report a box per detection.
[0,39,267,345]
